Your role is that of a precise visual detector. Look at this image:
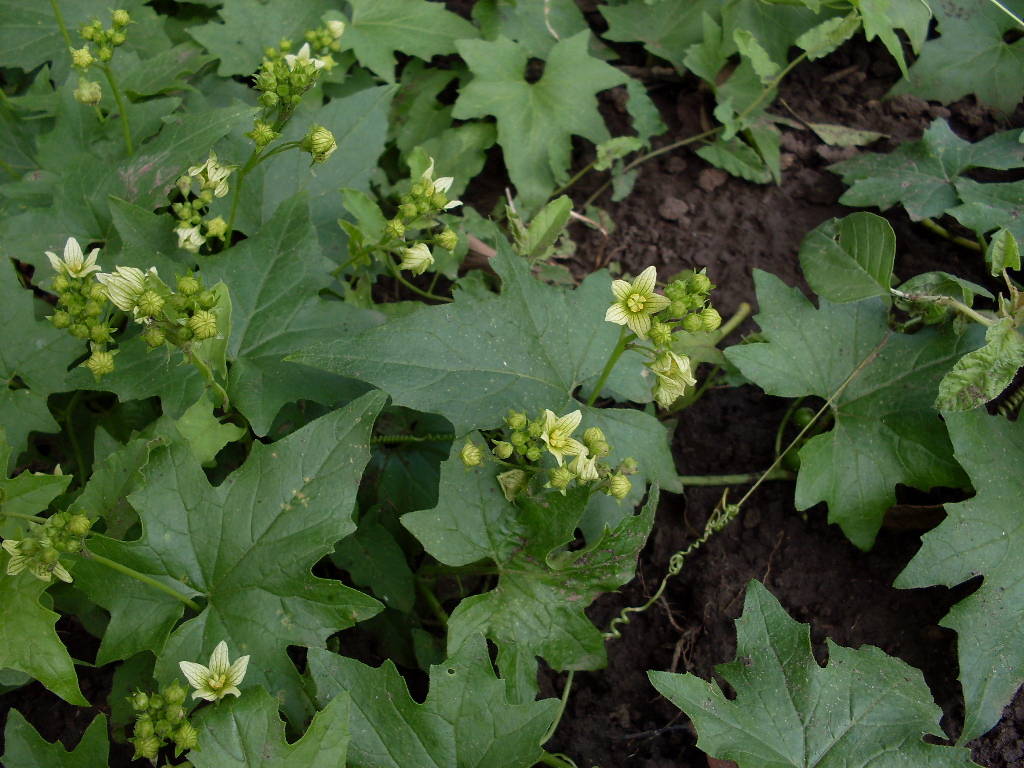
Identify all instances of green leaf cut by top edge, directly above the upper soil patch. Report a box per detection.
[598,0,732,71]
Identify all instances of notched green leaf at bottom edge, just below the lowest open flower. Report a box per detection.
[187,688,349,768]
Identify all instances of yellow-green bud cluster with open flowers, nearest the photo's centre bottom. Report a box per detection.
[459,411,637,502]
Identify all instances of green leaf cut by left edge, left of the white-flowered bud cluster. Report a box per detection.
[0,257,85,469]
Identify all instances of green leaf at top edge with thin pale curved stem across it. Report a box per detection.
[473,0,589,58]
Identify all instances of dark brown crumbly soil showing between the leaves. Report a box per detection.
[0,16,1024,768]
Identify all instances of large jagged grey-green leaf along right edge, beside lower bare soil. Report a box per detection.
[895,410,1024,743]
